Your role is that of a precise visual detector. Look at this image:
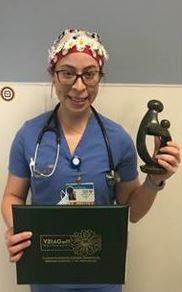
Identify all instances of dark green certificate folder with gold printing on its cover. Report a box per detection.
[12,205,128,284]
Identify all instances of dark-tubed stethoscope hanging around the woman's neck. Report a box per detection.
[29,103,120,187]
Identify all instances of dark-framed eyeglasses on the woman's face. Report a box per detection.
[55,69,103,86]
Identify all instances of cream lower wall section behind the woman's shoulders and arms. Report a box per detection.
[0,83,182,292]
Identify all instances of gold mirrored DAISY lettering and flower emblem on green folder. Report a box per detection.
[40,229,102,262]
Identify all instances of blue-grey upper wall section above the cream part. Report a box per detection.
[0,0,182,84]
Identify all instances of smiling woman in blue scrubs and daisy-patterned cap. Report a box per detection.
[2,30,180,292]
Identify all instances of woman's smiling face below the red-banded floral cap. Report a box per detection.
[53,52,100,112]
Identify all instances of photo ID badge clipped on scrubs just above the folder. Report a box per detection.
[58,183,95,205]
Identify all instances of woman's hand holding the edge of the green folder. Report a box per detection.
[5,227,32,263]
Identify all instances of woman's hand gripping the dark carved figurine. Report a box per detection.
[151,140,181,184]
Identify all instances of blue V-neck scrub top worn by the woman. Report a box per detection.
[9,109,138,292]
